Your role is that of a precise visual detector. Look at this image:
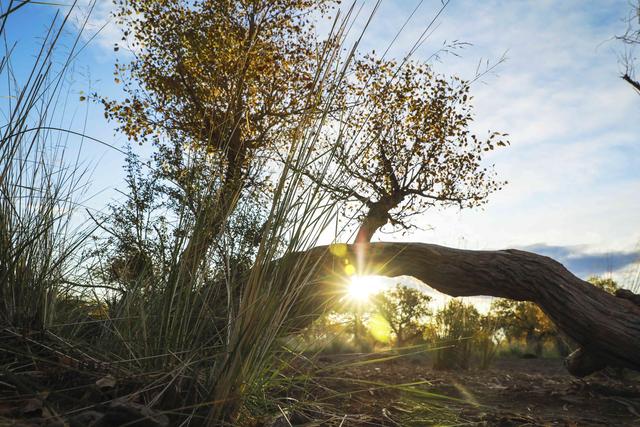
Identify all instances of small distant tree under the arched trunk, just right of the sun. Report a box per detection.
[373,284,431,347]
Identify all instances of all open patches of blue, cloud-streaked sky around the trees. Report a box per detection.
[1,0,640,286]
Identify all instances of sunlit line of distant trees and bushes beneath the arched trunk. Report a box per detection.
[303,276,618,369]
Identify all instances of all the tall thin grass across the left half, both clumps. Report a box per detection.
[0,3,470,426]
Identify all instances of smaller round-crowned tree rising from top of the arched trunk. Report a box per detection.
[316,55,508,242]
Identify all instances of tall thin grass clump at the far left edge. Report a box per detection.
[0,2,94,329]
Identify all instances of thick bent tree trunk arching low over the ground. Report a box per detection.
[285,243,640,376]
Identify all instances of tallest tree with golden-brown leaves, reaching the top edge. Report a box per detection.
[102,0,333,287]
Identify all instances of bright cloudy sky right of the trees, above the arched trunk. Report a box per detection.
[356,1,640,281]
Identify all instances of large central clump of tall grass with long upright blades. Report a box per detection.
[75,3,378,425]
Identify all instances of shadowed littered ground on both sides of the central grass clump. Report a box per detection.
[0,330,640,427]
